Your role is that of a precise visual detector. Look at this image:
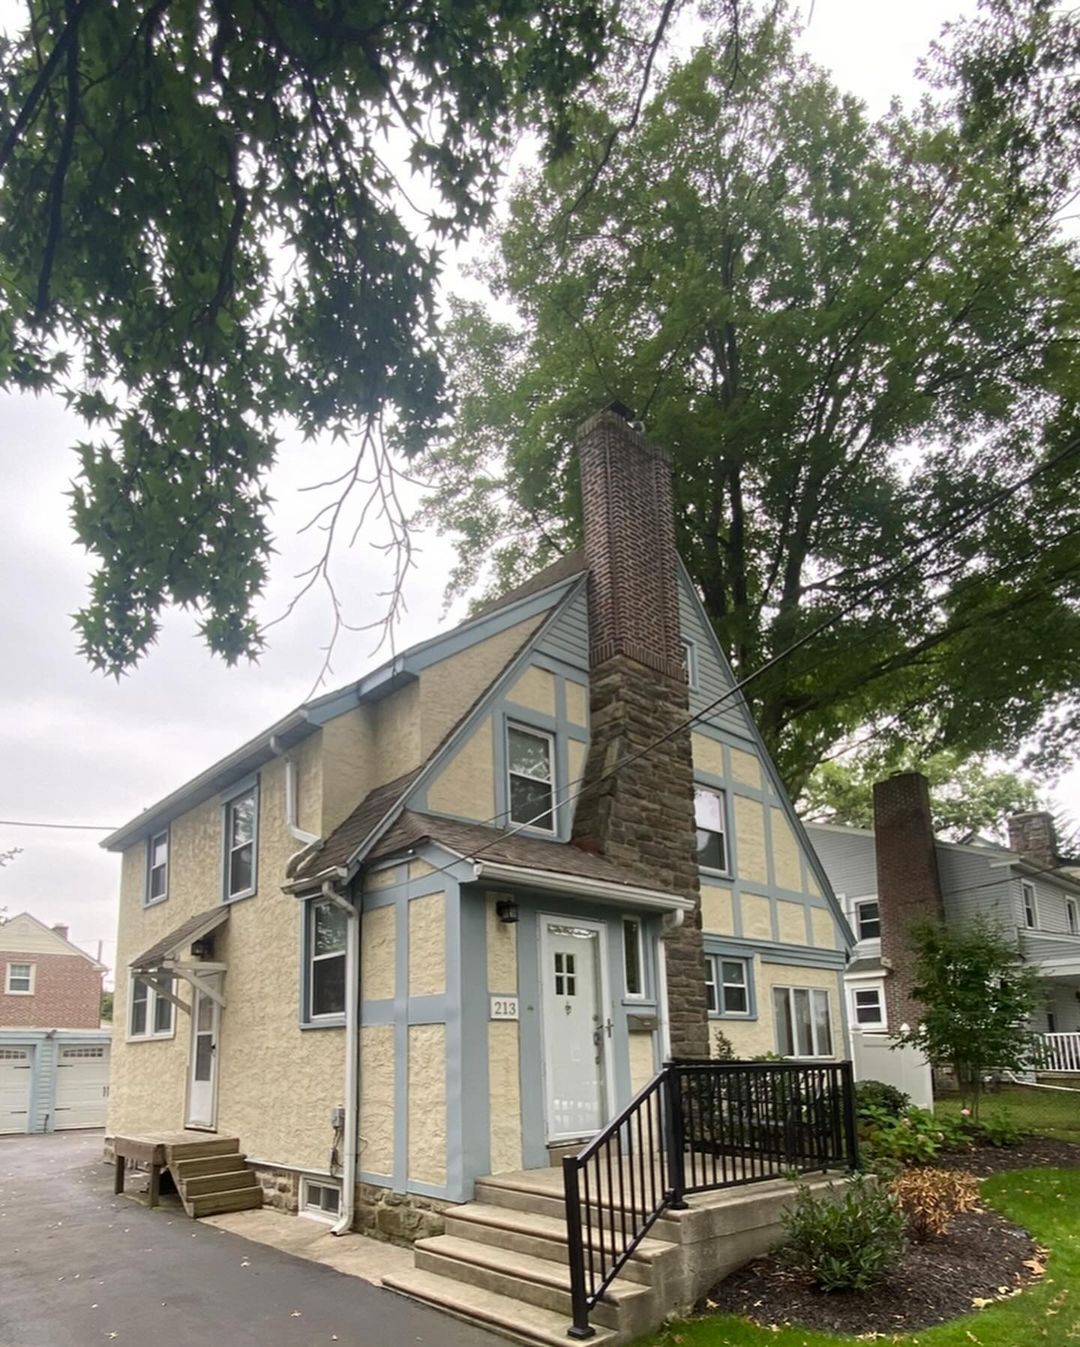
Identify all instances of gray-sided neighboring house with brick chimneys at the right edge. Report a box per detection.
[807,773,1080,1072]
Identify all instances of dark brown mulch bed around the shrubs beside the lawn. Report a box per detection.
[699,1137,1080,1334]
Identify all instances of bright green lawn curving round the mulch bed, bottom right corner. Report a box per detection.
[638,1169,1080,1347]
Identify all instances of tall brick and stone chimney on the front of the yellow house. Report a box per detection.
[574,404,710,1057]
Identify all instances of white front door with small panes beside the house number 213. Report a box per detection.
[540,917,611,1141]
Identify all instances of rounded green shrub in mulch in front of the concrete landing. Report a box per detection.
[780,1175,904,1290]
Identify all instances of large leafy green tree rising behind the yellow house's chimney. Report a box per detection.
[417,3,1080,791]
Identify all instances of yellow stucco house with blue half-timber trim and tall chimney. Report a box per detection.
[105,409,850,1336]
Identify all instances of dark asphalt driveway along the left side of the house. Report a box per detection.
[0,1133,505,1347]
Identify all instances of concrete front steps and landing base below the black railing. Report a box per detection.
[382,1169,842,1347]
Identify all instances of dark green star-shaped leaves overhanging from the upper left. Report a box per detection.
[0,0,614,672]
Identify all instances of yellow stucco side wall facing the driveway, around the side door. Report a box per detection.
[109,760,345,1168]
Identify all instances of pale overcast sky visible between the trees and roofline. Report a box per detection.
[0,0,1080,963]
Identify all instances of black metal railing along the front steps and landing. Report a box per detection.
[563,1061,859,1338]
